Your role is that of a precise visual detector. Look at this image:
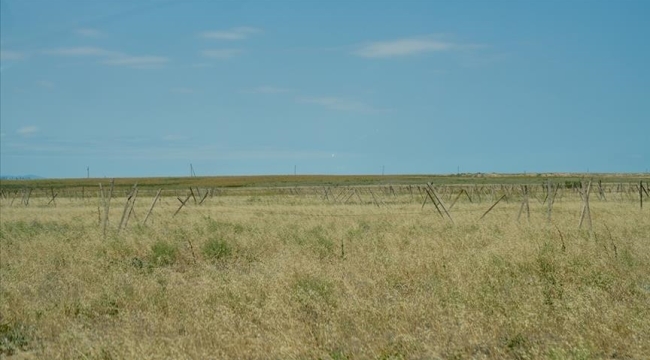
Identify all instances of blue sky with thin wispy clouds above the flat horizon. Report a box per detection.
[0,0,650,177]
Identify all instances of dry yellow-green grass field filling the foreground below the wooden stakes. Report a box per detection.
[0,183,650,359]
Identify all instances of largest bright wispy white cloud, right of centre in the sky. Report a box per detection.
[354,38,481,58]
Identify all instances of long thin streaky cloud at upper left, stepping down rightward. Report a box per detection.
[44,47,169,69]
